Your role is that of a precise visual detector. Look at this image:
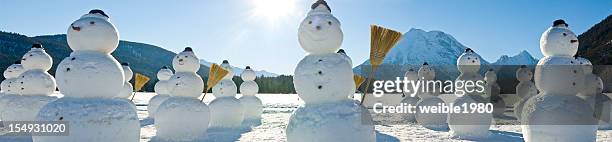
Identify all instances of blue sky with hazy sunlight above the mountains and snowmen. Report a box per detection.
[0,0,612,74]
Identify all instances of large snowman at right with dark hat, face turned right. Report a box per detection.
[521,20,597,142]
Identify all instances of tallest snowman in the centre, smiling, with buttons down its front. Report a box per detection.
[286,0,376,142]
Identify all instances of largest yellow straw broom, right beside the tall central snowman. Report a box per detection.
[361,25,402,105]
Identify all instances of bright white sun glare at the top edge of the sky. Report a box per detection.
[253,0,295,21]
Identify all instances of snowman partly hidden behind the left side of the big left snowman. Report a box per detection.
[2,44,57,121]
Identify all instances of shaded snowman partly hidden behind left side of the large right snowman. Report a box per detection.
[514,65,538,121]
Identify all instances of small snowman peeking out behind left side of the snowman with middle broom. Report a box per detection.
[147,66,174,118]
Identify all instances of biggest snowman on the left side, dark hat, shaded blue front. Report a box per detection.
[33,10,140,142]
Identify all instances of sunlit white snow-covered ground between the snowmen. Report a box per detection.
[0,93,612,142]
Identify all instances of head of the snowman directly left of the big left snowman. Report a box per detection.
[21,44,53,71]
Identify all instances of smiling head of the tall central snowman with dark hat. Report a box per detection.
[298,0,344,54]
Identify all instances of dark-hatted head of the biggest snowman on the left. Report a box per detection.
[67,9,119,54]
